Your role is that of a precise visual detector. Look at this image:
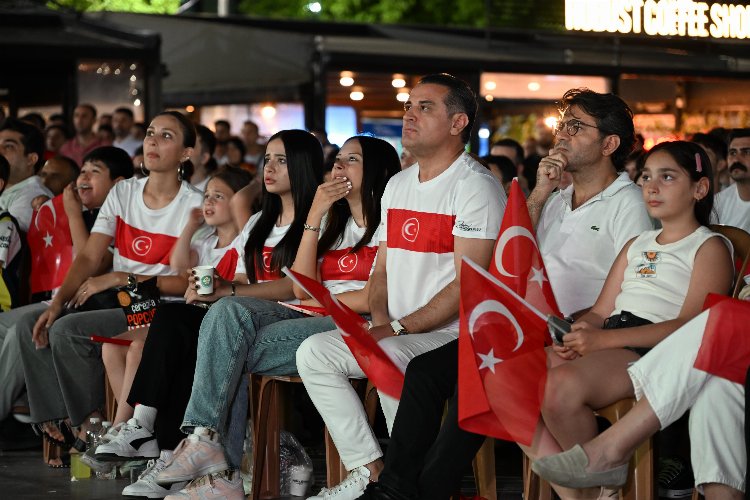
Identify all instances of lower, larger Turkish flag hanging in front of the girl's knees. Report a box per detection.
[458,258,547,445]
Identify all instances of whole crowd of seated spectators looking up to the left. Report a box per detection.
[0,74,750,500]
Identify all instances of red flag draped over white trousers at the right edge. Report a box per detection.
[692,298,750,384]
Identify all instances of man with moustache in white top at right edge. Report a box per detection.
[714,128,750,232]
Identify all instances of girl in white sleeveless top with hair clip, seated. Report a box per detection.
[527,141,733,497]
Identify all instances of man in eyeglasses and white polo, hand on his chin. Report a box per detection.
[527,89,652,315]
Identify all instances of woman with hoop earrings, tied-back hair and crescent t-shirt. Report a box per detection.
[17,111,201,460]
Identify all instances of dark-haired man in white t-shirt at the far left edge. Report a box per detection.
[0,118,54,232]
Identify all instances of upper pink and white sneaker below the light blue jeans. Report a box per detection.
[156,428,229,484]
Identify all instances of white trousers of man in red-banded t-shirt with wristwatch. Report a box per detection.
[297,330,458,470]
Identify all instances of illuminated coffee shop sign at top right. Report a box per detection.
[565,0,750,39]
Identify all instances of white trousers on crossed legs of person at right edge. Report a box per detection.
[628,311,747,491]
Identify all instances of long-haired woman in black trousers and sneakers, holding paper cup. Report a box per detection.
[96,130,323,495]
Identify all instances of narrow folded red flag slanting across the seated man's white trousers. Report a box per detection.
[284,268,404,399]
